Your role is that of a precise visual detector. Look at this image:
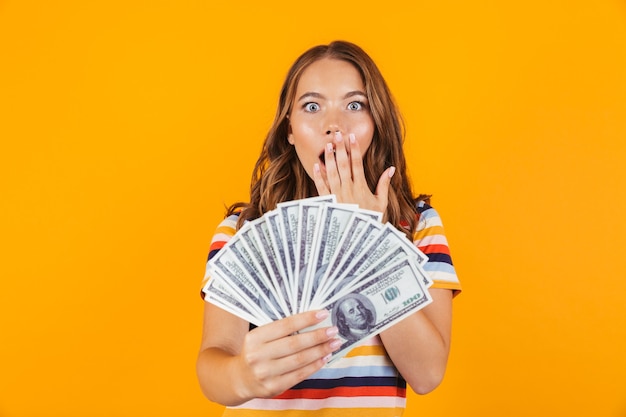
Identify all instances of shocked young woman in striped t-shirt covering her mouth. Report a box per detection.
[197,41,460,417]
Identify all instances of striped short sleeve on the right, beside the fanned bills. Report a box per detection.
[413,201,461,295]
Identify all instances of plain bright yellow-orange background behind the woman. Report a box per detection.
[0,0,626,417]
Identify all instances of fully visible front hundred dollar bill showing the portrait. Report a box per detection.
[305,259,432,362]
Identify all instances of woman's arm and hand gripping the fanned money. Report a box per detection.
[196,303,339,405]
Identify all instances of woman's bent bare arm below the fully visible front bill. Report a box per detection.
[380,289,452,394]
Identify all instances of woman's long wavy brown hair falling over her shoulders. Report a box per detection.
[227,41,428,239]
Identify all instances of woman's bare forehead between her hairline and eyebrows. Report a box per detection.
[296,58,365,93]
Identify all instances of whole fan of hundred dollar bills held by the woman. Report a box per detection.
[204,195,432,361]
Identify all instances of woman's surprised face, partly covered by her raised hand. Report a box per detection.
[288,58,374,178]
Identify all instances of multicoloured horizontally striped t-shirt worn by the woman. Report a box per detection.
[200,202,461,417]
